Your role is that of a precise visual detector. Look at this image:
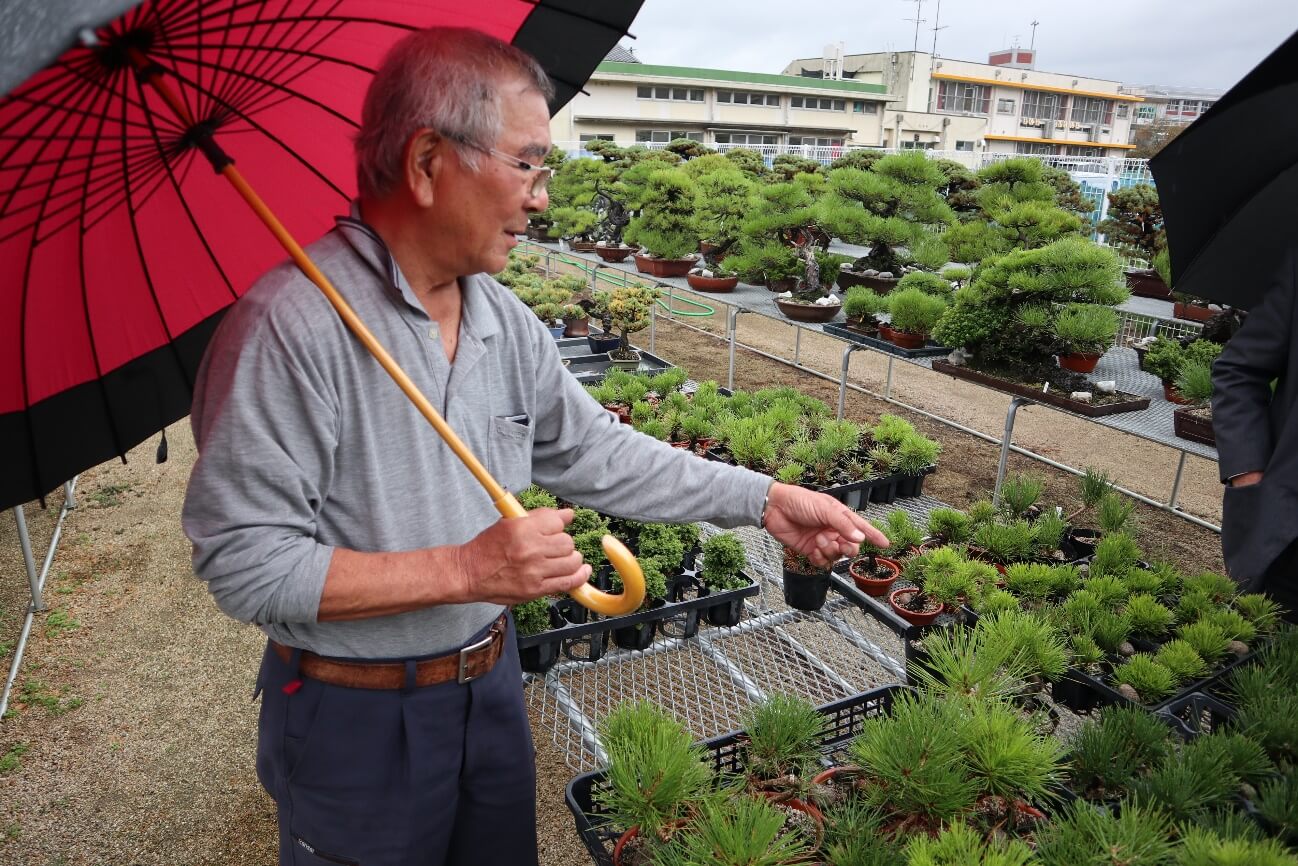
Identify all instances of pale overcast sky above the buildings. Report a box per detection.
[623,0,1298,90]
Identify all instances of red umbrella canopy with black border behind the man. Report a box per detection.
[0,0,641,508]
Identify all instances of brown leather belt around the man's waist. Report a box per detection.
[270,614,506,688]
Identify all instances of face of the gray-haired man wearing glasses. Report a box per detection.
[431,79,550,277]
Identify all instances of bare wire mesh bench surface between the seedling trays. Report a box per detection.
[526,497,941,771]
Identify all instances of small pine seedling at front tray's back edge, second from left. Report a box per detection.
[740,695,828,780]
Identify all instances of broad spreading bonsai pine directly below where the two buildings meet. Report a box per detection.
[820,152,954,277]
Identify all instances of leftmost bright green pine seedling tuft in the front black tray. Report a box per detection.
[597,701,711,837]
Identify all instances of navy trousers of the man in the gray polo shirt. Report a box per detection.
[257,619,536,866]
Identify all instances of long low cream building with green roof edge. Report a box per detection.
[550,51,893,155]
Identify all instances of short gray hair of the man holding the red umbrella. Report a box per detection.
[356,27,554,197]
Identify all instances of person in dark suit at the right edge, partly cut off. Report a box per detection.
[1212,247,1298,622]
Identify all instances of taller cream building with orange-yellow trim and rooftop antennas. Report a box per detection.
[784,48,1142,157]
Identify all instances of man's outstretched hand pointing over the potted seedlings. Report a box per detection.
[766,482,888,569]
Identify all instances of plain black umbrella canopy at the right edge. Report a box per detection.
[1149,28,1298,309]
